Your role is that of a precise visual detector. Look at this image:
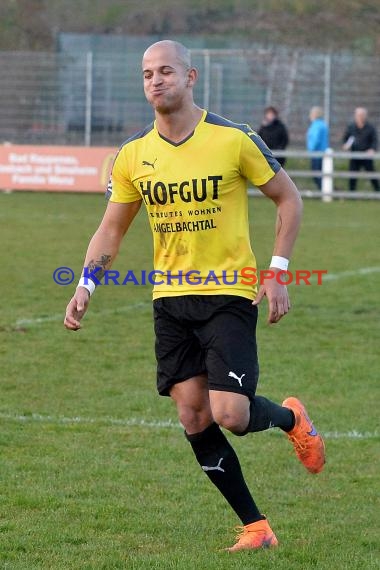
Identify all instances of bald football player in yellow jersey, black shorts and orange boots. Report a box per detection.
[64,40,325,552]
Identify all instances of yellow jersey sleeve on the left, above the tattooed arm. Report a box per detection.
[106,147,141,204]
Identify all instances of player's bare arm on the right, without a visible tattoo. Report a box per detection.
[254,168,302,323]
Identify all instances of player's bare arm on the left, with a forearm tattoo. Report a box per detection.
[64,200,141,331]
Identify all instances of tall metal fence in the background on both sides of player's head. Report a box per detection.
[0,48,380,148]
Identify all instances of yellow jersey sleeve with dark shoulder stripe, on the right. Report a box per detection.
[239,125,281,186]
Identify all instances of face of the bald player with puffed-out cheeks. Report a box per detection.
[143,47,193,114]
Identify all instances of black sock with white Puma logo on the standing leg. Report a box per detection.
[185,423,265,525]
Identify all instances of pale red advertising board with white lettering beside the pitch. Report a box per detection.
[0,144,117,192]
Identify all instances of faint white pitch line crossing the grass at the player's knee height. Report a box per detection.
[0,412,380,440]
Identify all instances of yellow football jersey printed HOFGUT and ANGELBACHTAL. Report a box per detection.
[108,111,281,299]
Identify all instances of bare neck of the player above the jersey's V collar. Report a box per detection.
[156,105,203,143]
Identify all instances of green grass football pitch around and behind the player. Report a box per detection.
[0,193,380,570]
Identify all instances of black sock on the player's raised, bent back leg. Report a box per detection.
[236,396,295,435]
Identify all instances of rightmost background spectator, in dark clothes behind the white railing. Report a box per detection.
[343,107,380,192]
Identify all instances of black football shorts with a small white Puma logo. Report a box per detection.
[153,295,259,399]
